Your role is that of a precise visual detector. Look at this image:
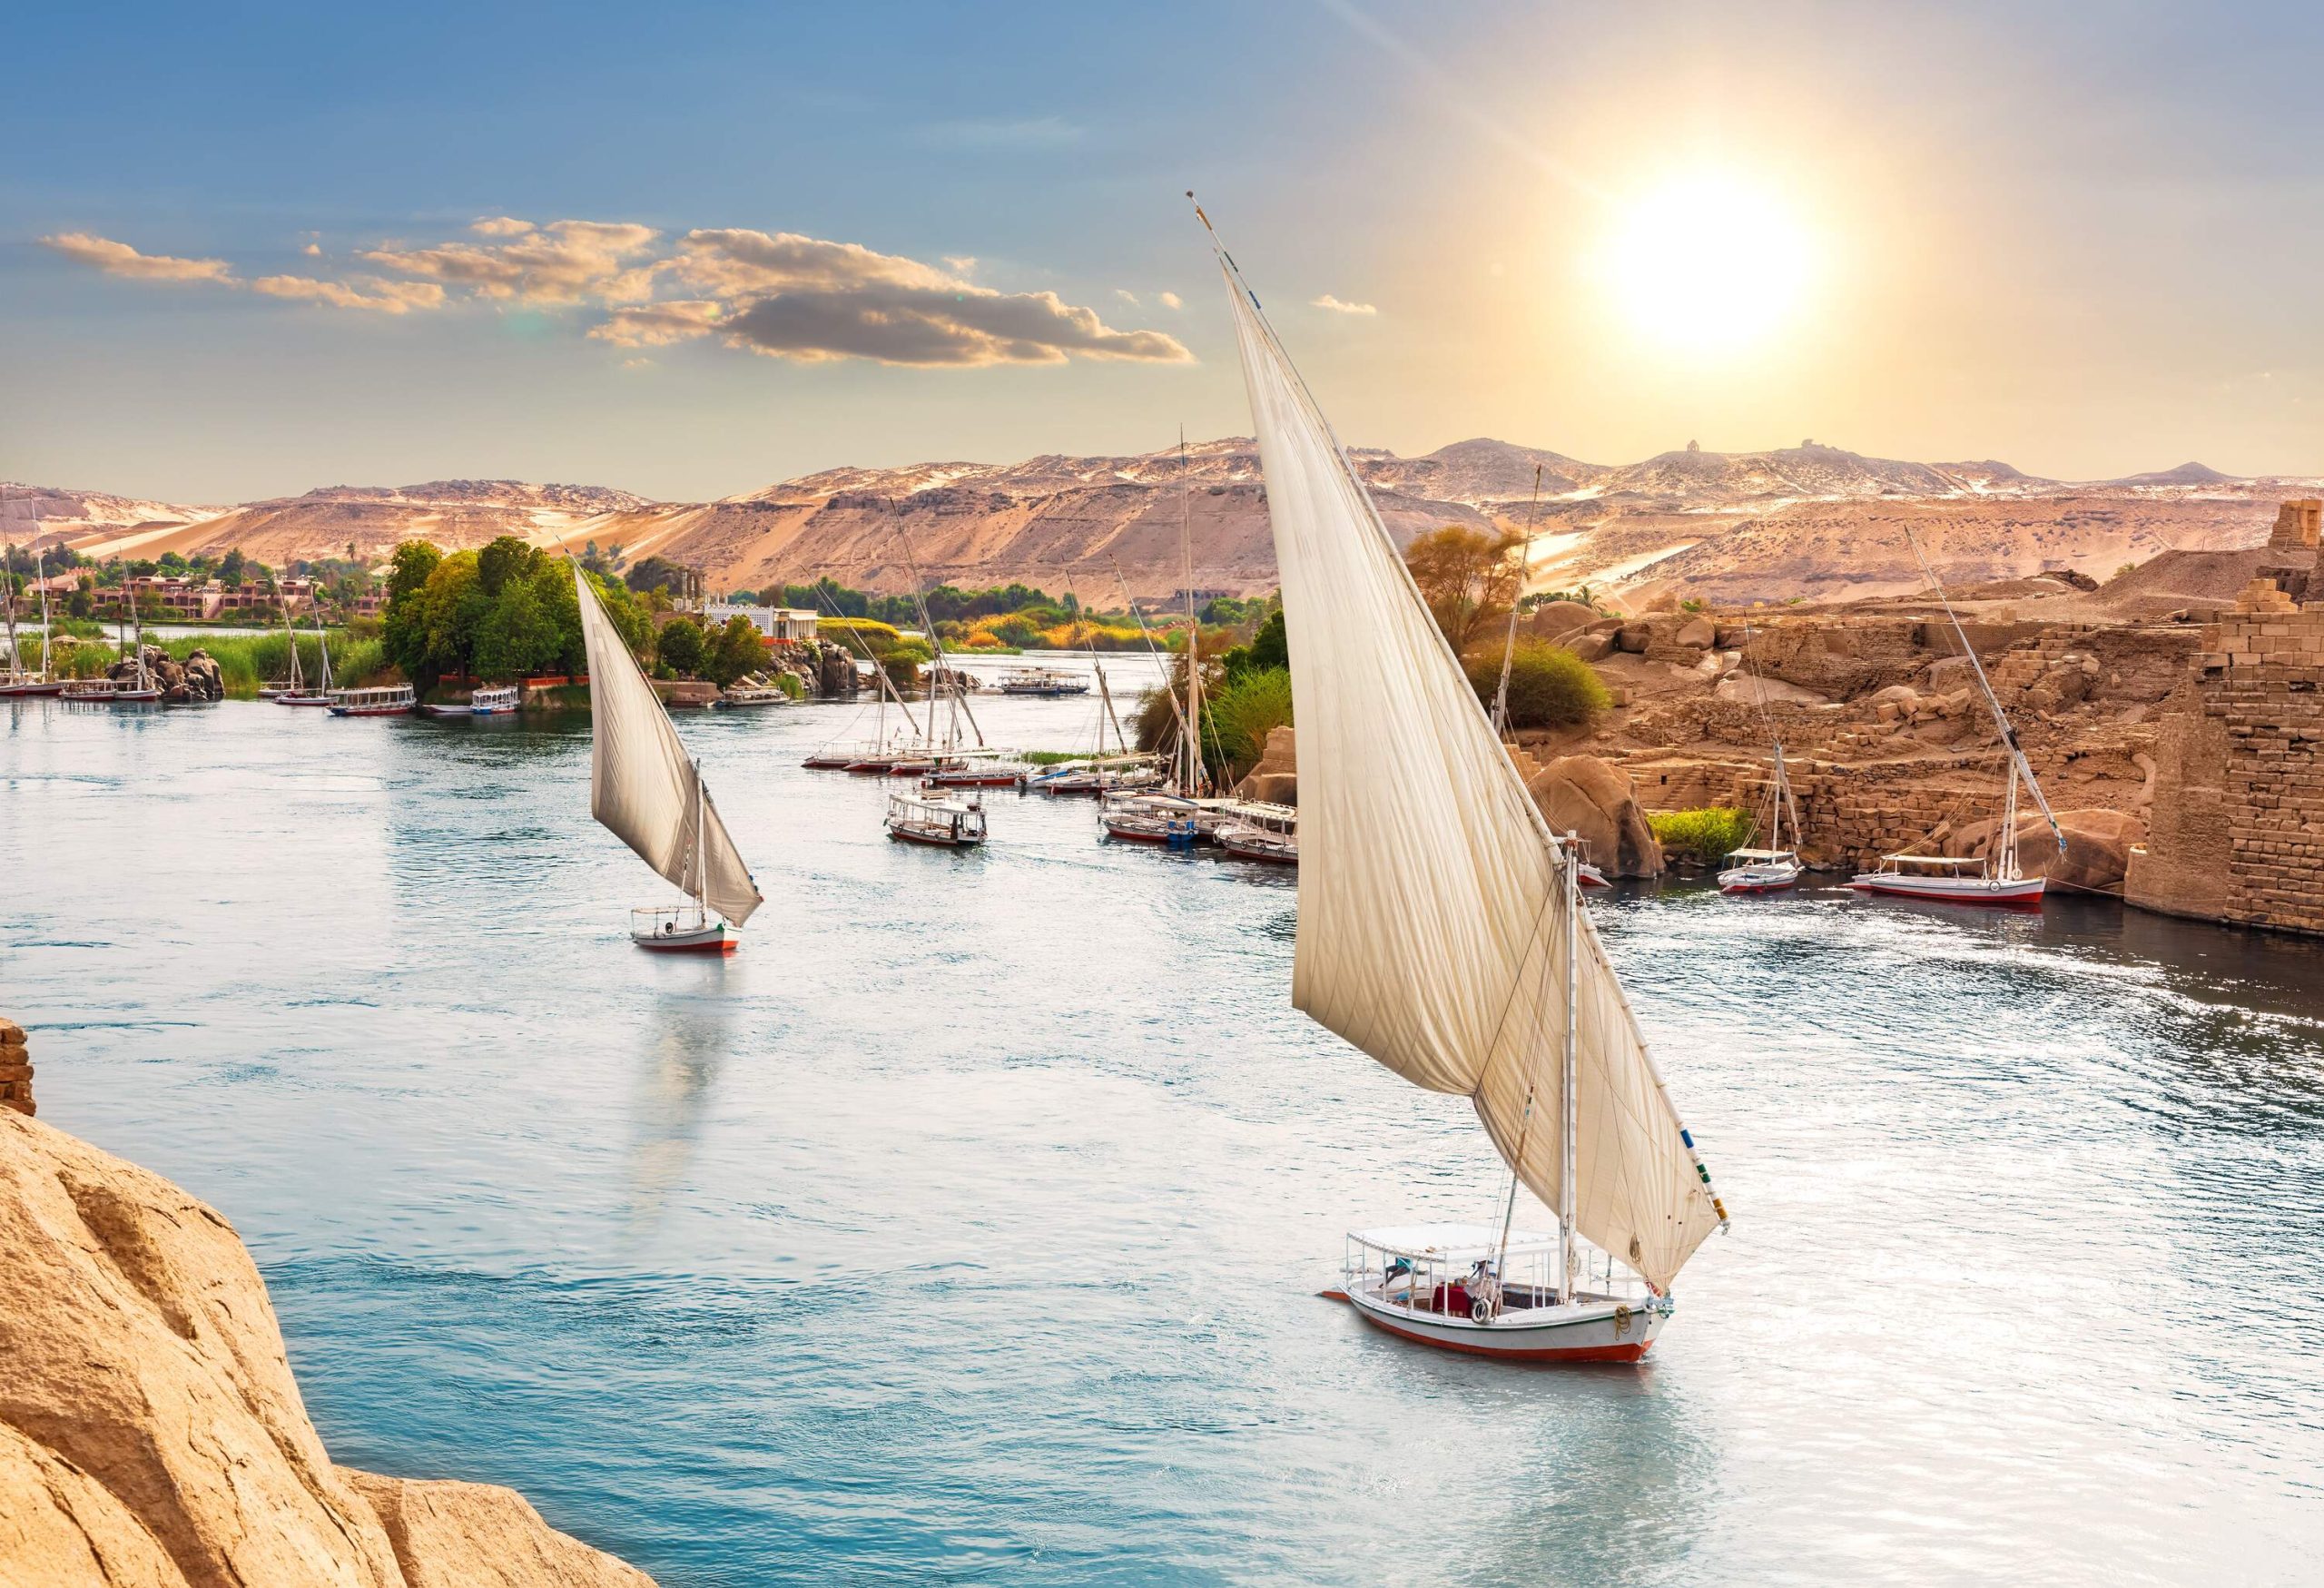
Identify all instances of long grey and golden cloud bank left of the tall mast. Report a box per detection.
[42,216,1189,368]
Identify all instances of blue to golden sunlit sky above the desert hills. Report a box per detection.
[0,0,2324,500]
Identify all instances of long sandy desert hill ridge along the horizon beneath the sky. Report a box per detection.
[0,437,2319,605]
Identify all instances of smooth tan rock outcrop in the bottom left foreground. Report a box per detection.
[0,1109,653,1588]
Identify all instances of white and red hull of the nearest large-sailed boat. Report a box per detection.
[1324,1223,1676,1363]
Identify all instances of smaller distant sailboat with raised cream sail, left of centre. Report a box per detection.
[574,563,763,953]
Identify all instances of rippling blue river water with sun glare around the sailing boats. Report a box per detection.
[0,678,2324,1585]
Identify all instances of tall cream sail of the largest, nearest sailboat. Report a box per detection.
[1220,252,1725,1290]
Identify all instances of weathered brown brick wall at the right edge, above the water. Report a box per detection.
[2124,605,2324,932]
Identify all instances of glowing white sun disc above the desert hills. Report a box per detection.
[1597,170,1815,356]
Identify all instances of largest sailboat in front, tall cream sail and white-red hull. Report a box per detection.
[1195,198,1727,1363]
